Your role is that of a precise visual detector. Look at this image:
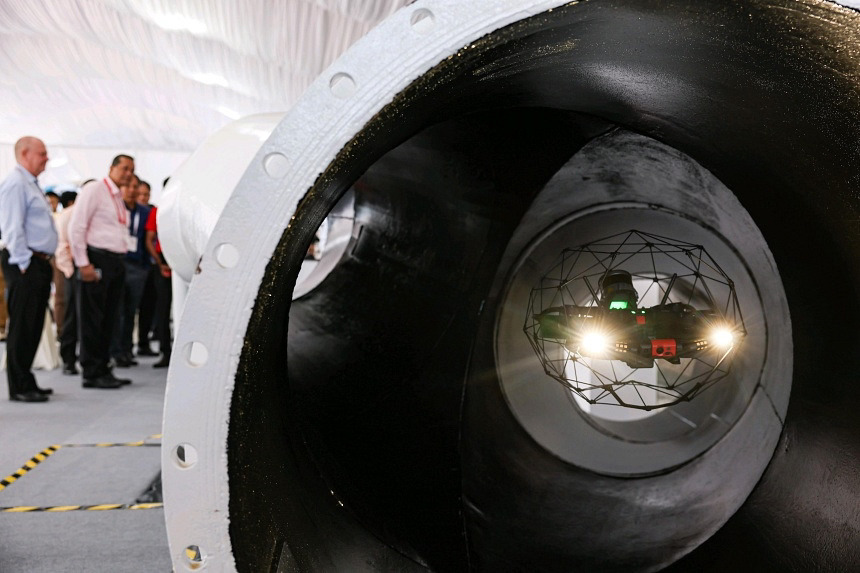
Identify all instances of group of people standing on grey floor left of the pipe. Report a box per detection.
[0,136,172,403]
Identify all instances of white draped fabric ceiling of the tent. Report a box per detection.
[0,0,409,154]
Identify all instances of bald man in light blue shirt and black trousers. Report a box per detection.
[0,137,57,402]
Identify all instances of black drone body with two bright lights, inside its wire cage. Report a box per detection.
[533,269,745,368]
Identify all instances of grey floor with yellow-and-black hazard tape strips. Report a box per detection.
[0,344,172,573]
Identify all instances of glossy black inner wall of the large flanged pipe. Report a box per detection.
[229,0,860,571]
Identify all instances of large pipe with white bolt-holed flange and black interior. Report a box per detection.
[159,0,860,572]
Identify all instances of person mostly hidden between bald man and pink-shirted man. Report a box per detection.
[54,191,79,375]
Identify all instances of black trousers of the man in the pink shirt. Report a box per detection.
[77,247,125,378]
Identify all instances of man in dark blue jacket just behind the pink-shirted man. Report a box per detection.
[111,175,149,368]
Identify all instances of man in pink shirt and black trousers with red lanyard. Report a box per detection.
[69,155,134,388]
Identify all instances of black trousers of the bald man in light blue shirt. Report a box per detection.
[0,249,53,396]
